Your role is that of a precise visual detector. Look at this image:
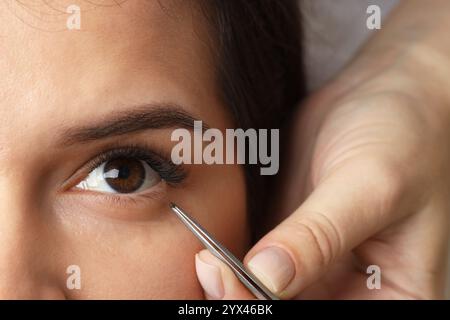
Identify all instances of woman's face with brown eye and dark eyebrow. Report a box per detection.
[0,0,247,299]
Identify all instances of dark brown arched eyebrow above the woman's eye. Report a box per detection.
[58,104,209,146]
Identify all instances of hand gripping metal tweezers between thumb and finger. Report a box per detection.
[196,46,450,299]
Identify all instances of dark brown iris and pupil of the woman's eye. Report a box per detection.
[103,157,145,193]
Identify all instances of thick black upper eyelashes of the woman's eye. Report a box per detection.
[83,144,187,187]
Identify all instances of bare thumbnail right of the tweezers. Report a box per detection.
[247,247,295,293]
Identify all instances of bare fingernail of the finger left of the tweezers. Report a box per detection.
[195,253,224,299]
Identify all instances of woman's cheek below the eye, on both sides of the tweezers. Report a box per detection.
[53,165,248,299]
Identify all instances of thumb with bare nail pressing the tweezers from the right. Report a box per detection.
[245,159,419,298]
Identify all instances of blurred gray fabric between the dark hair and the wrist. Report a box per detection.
[299,0,399,90]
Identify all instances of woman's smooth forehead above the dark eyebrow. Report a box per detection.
[0,0,224,140]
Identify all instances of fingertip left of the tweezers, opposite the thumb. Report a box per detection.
[195,250,255,300]
